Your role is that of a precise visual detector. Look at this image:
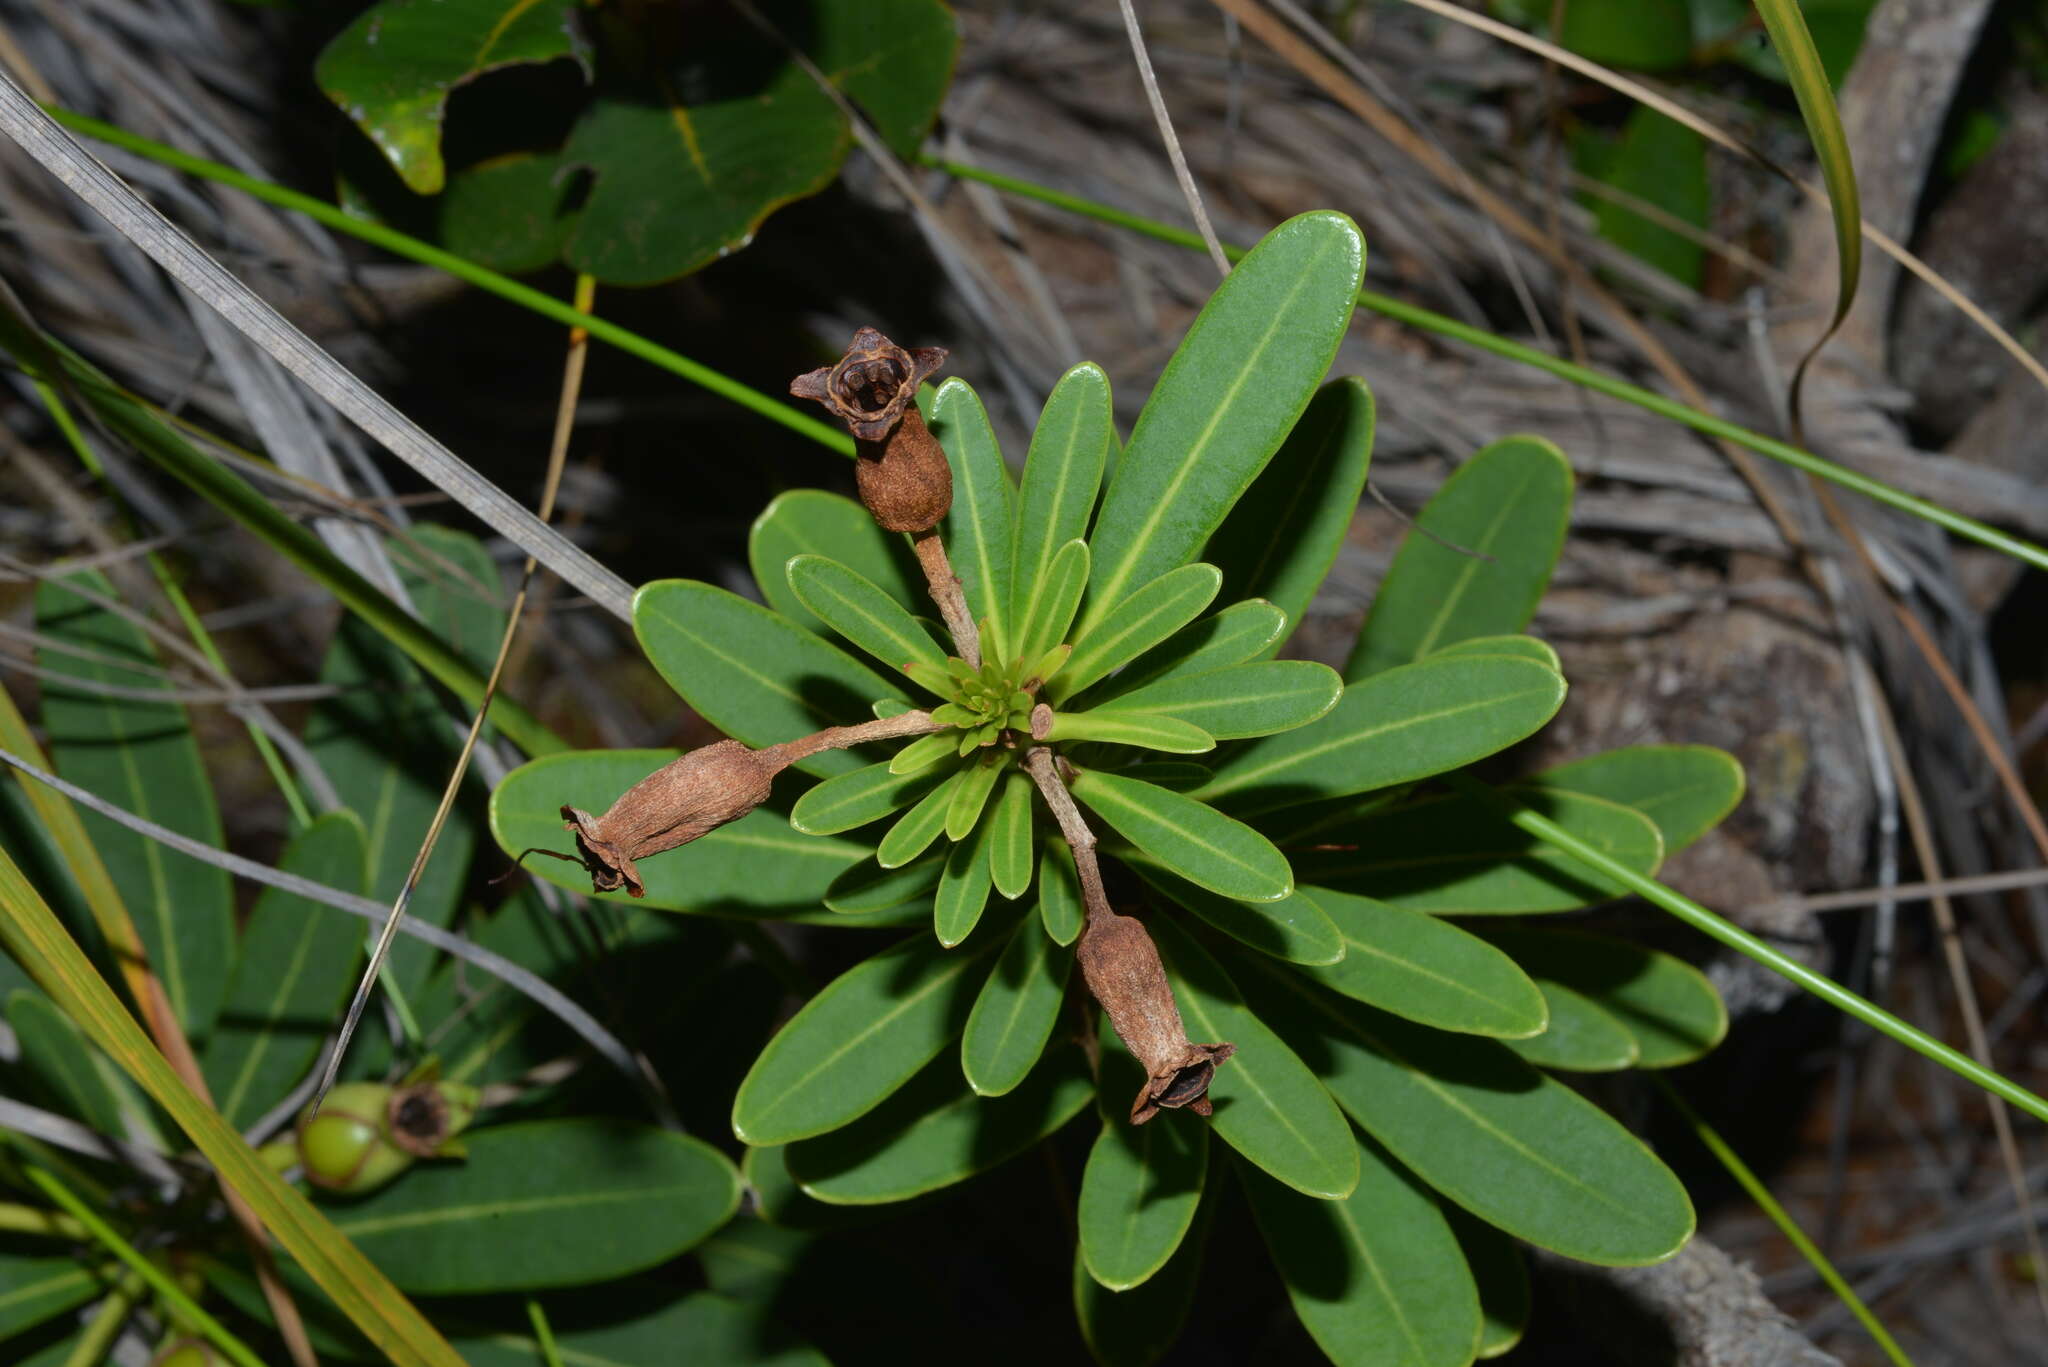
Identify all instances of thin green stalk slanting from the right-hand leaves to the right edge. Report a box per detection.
[1444,773,2048,1121]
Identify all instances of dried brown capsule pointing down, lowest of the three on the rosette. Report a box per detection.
[1075,912,1237,1125]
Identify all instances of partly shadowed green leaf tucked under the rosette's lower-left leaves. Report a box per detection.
[786,1049,1096,1205]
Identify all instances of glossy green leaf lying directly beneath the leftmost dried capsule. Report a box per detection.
[492,750,901,926]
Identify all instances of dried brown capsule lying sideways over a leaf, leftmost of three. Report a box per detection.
[561,740,788,898]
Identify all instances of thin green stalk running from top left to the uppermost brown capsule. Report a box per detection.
[47,105,854,459]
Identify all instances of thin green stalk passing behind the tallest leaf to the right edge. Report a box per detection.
[926,158,2048,570]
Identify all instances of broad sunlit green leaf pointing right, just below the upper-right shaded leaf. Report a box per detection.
[1196,656,1565,812]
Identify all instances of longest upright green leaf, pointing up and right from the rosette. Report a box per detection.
[1081,211,1366,633]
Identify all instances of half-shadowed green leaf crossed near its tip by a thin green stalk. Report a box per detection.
[1300,787,1663,916]
